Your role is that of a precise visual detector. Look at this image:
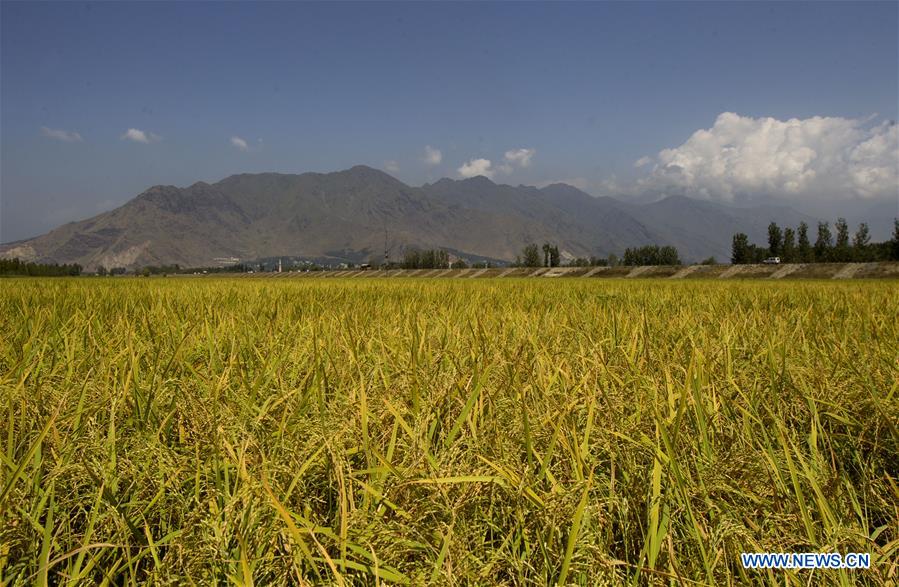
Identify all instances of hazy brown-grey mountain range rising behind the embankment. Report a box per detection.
[0,165,816,268]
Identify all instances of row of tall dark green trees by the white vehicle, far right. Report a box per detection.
[730,218,899,265]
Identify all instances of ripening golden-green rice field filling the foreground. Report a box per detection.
[0,278,899,585]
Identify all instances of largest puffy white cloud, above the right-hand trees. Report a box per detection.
[638,112,899,200]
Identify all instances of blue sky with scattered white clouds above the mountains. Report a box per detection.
[0,2,899,242]
